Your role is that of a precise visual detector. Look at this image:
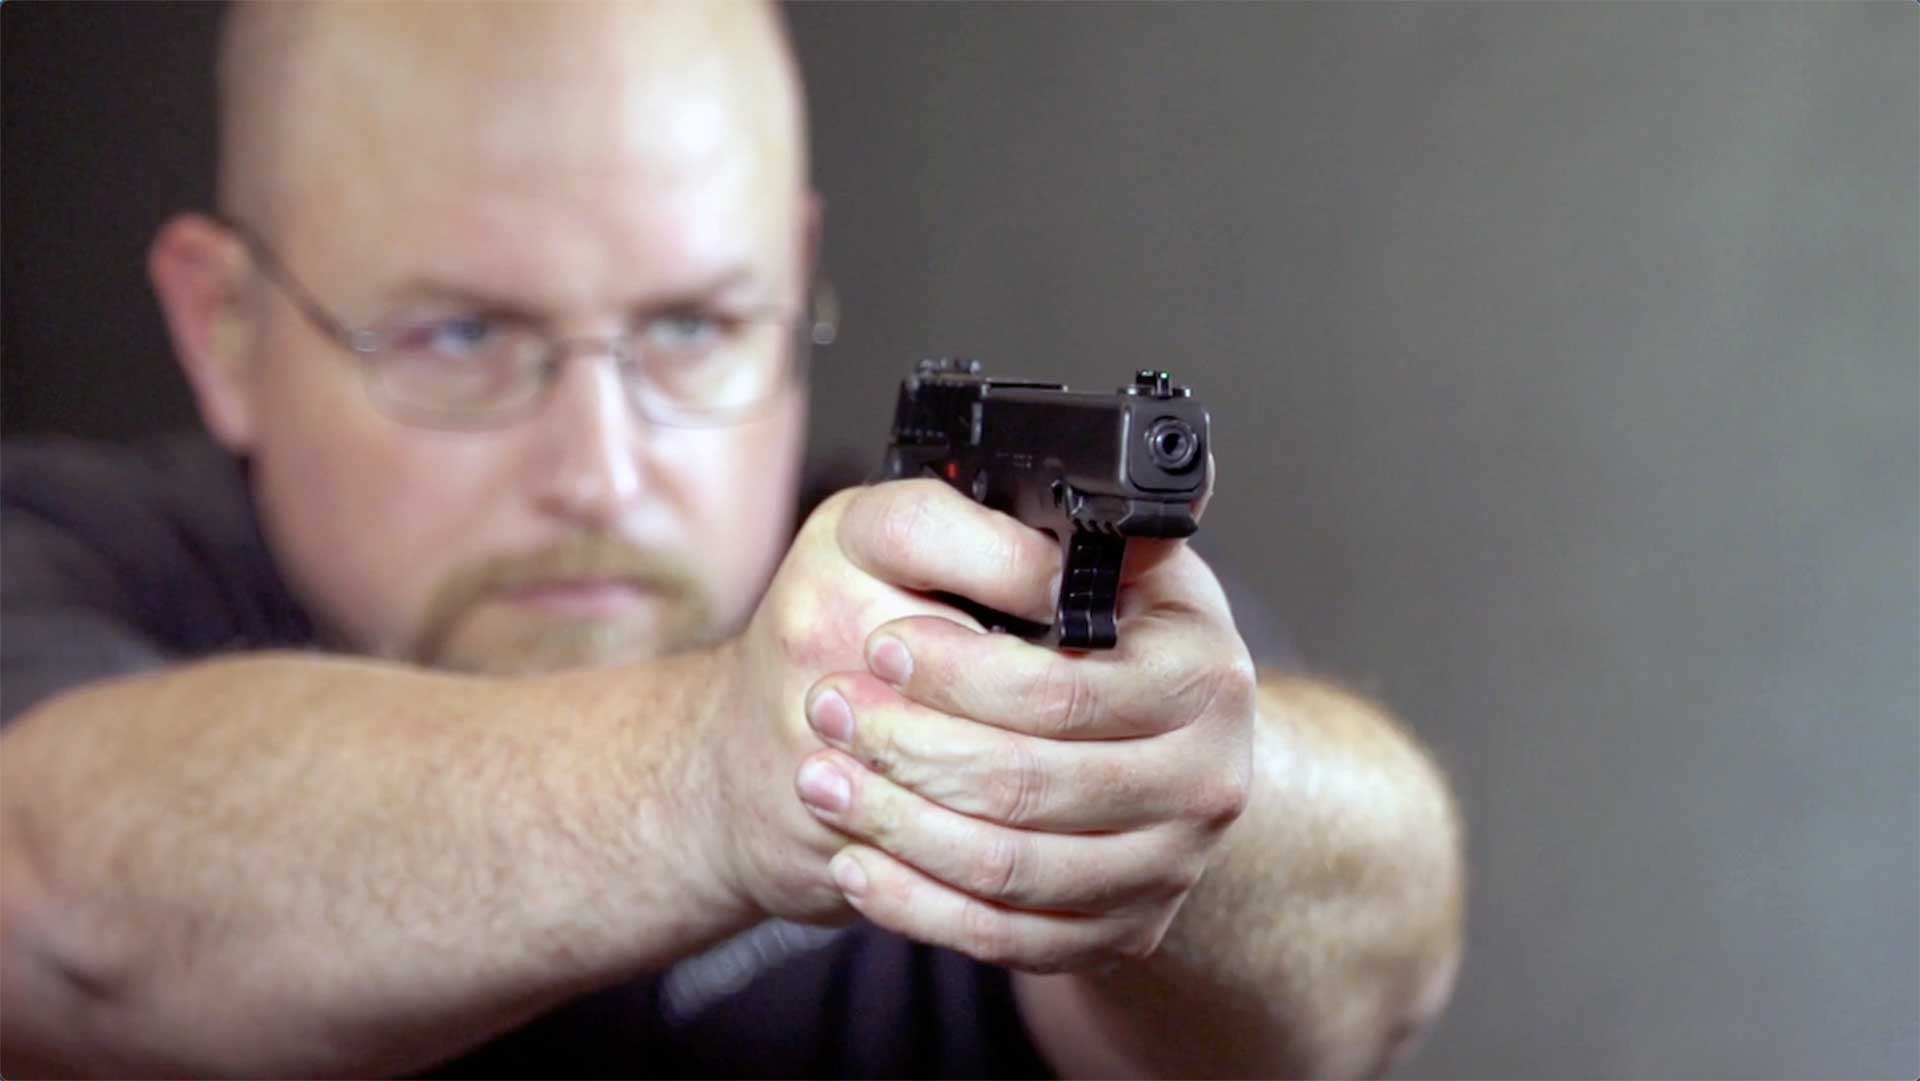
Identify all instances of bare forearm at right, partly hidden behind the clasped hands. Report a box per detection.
[1020,680,1465,1077]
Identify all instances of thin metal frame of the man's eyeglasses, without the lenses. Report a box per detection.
[209,215,839,432]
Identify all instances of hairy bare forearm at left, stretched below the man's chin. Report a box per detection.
[0,657,747,1073]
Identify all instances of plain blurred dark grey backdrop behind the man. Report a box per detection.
[0,2,1920,1077]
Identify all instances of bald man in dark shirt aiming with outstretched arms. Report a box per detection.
[0,4,1461,1075]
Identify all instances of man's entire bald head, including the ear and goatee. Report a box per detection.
[165,0,818,670]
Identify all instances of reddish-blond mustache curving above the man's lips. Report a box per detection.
[409,534,708,664]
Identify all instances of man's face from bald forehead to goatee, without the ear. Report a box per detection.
[216,6,810,672]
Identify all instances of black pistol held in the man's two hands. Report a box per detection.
[881,357,1208,649]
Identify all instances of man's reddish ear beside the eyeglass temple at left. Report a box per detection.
[146,213,257,455]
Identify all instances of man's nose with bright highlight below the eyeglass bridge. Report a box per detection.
[536,349,643,530]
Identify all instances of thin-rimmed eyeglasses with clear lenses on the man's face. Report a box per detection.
[223,219,839,430]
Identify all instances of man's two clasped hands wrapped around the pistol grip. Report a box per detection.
[733,482,1254,972]
